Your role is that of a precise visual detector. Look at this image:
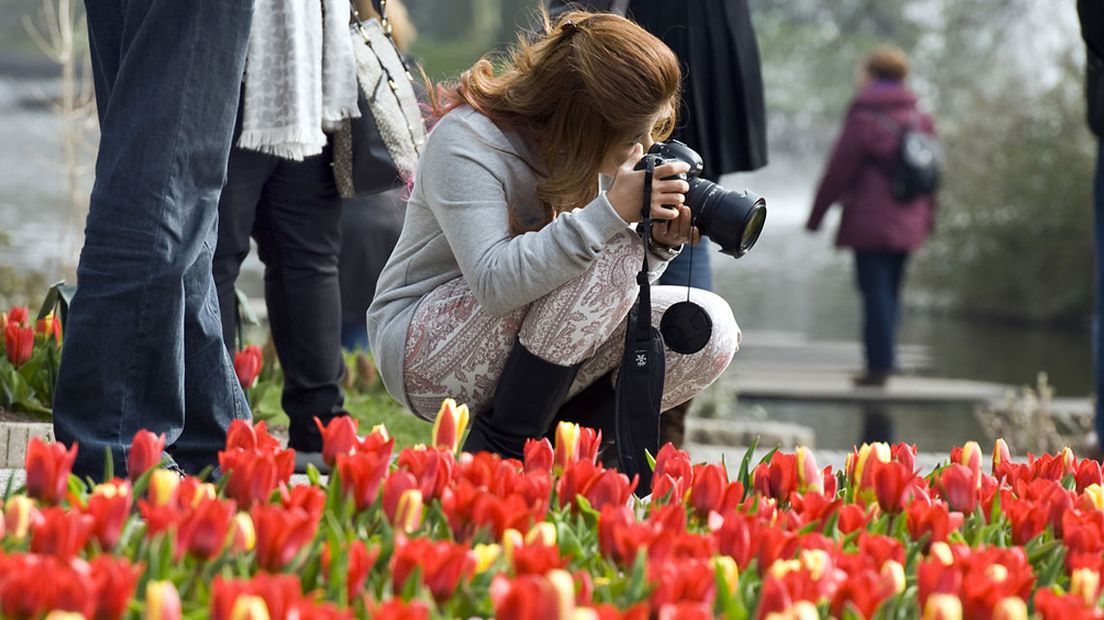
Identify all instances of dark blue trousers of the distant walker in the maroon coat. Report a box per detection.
[854,250,909,373]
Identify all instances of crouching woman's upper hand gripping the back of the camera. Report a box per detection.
[606,145,690,223]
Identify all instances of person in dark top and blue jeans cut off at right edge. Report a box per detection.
[1078,0,1104,459]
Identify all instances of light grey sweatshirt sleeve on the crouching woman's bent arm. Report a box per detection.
[418,118,628,316]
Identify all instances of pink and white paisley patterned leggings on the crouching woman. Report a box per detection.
[404,229,741,419]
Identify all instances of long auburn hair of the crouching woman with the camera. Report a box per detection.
[429,11,681,232]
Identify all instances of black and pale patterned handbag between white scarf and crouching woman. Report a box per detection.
[333,0,425,197]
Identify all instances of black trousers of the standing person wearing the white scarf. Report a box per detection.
[214,148,344,451]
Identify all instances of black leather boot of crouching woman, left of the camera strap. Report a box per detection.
[464,342,583,459]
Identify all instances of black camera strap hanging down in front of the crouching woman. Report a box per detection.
[614,157,666,498]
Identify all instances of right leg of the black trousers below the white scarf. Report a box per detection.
[253,149,344,451]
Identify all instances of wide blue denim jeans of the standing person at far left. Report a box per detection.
[54,0,253,478]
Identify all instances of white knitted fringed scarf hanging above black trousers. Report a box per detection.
[237,0,360,161]
